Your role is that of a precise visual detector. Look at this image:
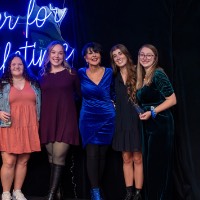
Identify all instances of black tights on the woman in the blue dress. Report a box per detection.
[86,144,108,188]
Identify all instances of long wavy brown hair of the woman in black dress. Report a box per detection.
[110,44,136,103]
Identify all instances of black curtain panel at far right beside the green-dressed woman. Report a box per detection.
[173,0,200,200]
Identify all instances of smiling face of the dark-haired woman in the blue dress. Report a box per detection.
[84,49,101,66]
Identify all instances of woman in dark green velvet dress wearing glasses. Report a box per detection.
[137,44,176,200]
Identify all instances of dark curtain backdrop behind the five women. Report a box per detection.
[0,0,200,200]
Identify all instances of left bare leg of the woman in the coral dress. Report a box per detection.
[1,152,17,192]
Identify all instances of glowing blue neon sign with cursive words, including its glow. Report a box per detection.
[0,0,74,70]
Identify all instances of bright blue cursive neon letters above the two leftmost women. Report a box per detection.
[0,0,74,70]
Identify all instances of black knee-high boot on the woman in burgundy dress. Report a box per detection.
[46,164,64,200]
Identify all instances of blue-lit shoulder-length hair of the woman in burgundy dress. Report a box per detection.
[40,41,71,75]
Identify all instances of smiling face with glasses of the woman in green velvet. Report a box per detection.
[138,47,156,70]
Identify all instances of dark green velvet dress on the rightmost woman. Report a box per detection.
[137,69,174,200]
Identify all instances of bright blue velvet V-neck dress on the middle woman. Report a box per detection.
[78,68,115,147]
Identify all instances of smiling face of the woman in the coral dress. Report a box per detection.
[10,57,24,78]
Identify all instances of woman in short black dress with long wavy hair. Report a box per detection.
[110,44,143,200]
